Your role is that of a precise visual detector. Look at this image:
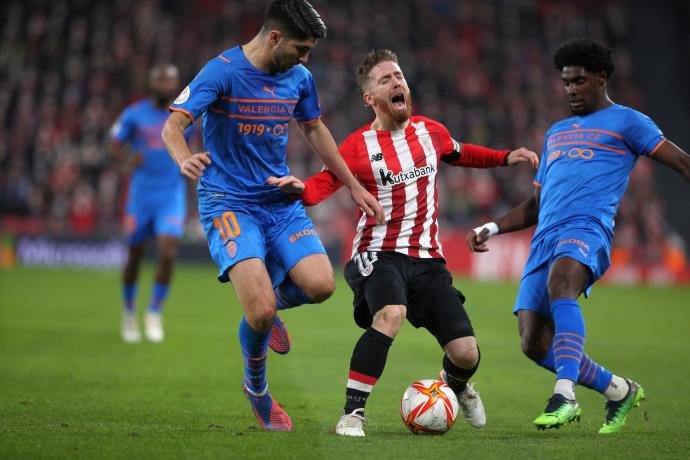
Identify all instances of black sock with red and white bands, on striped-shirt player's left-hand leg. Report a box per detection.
[344,327,393,414]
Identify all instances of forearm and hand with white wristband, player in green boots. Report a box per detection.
[465,187,541,252]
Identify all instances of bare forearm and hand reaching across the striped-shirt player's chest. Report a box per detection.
[297,119,385,224]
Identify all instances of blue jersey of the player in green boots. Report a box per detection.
[534,104,665,239]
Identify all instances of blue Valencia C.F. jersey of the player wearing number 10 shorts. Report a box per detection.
[170,46,321,207]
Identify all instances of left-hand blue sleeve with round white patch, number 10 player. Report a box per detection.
[170,57,230,121]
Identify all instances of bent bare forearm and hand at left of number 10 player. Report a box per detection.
[161,112,211,180]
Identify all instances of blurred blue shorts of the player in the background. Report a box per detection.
[125,193,187,246]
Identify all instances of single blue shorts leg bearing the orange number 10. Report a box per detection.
[200,208,266,283]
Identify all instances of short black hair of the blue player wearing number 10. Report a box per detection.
[261,0,326,40]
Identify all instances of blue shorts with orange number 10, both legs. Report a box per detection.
[200,202,326,287]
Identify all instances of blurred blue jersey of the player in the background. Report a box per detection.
[110,99,194,200]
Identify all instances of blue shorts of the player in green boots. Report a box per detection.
[513,220,611,318]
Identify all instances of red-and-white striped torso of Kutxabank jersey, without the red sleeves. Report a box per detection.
[352,119,443,258]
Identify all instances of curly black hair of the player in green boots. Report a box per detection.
[553,38,615,79]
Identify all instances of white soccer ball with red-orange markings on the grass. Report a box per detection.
[400,379,460,434]
